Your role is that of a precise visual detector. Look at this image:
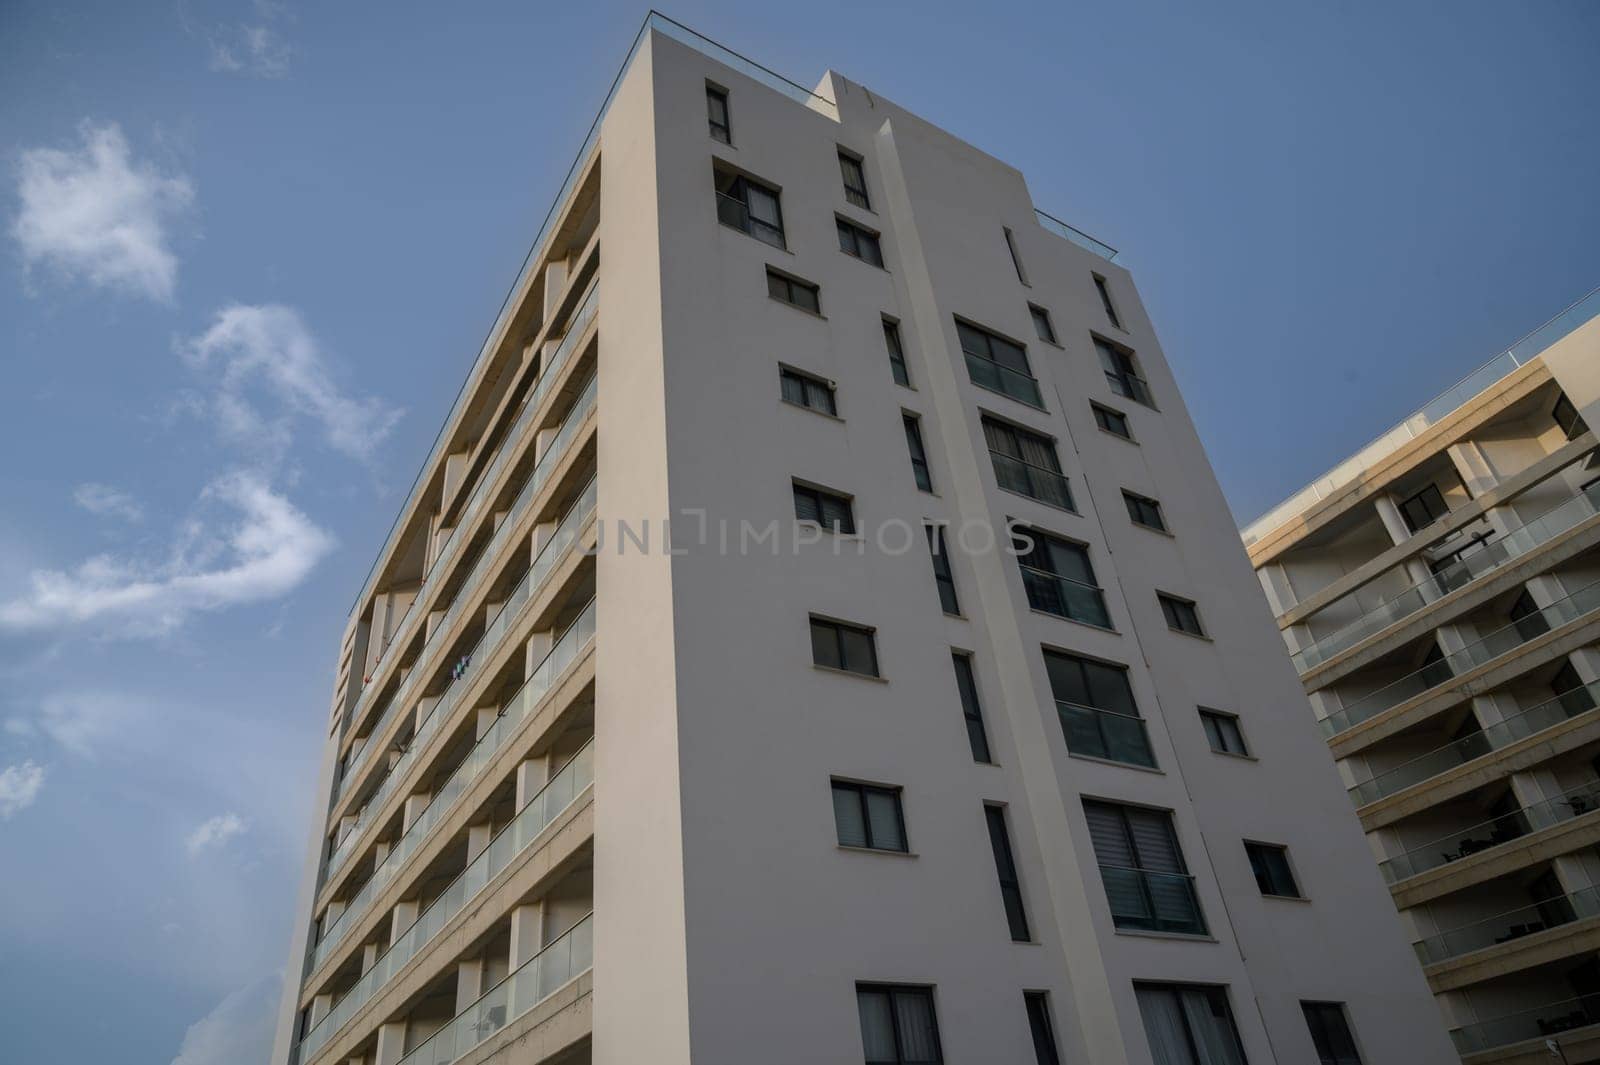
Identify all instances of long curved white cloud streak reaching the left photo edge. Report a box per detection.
[0,473,333,636]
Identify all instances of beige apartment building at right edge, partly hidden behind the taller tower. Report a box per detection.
[1245,291,1600,1065]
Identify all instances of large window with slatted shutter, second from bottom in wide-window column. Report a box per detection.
[1083,800,1206,935]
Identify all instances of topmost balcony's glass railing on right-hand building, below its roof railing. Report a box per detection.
[1291,483,1600,673]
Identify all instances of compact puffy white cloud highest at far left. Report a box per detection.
[11,122,194,302]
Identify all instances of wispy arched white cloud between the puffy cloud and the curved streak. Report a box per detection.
[181,304,402,459]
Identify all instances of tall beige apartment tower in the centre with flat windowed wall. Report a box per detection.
[274,16,1453,1065]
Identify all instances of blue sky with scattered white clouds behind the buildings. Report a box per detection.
[0,0,1600,1065]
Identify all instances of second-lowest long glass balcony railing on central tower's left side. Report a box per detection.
[298,729,594,1060]
